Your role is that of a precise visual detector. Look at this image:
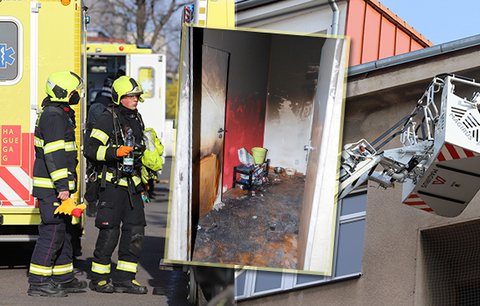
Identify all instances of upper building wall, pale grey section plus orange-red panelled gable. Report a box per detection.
[237,0,432,66]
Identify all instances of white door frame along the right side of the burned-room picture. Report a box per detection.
[298,40,347,275]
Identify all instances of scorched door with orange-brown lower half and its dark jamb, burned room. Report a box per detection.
[191,41,229,255]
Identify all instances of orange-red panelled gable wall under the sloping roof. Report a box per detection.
[346,0,432,66]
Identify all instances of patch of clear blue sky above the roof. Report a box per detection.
[378,0,480,45]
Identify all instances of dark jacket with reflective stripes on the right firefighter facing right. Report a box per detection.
[84,105,145,192]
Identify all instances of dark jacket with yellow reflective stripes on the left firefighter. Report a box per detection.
[33,97,78,198]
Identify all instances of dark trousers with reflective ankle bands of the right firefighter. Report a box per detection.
[92,183,146,282]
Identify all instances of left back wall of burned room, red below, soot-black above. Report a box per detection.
[204,29,270,188]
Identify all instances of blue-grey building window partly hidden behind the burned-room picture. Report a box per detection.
[235,192,367,300]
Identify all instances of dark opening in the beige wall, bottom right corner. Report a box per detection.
[417,219,480,306]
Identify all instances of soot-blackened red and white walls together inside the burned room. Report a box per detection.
[204,29,325,188]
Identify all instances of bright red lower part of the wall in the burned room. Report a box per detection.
[222,95,266,189]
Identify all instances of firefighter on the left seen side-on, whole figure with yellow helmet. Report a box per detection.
[27,71,87,297]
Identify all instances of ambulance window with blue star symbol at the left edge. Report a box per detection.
[0,17,23,85]
